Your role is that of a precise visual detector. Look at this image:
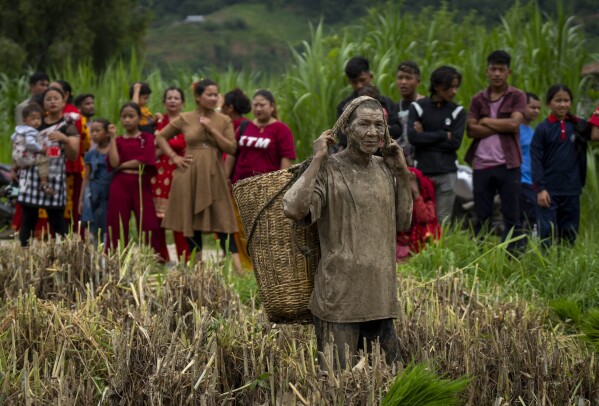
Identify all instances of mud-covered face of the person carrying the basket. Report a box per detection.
[347,107,386,155]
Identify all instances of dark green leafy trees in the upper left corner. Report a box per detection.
[0,0,150,76]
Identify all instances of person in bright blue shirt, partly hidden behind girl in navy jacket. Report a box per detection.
[520,92,541,236]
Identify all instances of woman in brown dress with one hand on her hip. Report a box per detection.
[157,79,239,268]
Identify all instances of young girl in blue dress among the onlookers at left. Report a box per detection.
[79,118,114,242]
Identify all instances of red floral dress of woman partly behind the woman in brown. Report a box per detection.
[151,114,187,218]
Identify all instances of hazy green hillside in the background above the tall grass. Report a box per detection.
[144,0,599,73]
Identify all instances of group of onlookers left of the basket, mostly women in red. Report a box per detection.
[12,73,296,271]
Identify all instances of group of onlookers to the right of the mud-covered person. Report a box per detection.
[337,50,599,260]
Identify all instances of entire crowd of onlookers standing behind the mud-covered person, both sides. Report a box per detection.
[11,51,599,271]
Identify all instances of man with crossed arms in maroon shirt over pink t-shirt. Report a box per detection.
[465,50,526,249]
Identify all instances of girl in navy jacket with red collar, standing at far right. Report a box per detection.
[530,84,594,245]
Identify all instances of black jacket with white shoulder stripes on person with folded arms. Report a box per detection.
[408,97,466,175]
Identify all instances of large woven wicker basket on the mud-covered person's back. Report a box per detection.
[233,164,320,323]
